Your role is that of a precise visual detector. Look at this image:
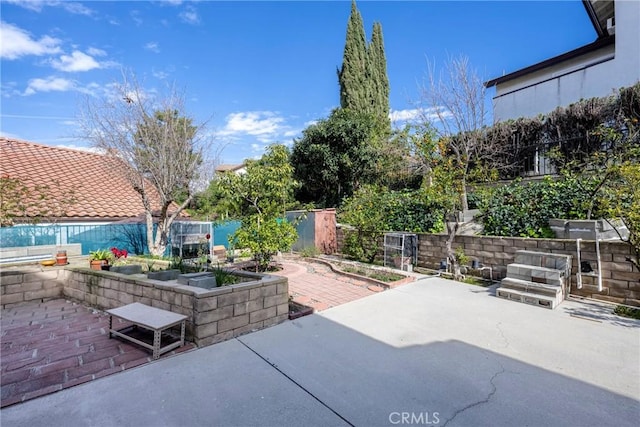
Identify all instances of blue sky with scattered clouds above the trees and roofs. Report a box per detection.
[0,0,596,163]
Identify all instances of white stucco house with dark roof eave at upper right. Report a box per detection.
[485,0,640,122]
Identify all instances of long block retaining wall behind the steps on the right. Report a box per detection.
[337,228,640,306]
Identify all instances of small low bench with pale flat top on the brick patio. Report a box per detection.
[106,302,187,359]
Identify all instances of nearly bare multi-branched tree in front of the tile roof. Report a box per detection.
[80,72,209,255]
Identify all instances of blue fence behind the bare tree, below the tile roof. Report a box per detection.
[0,222,240,255]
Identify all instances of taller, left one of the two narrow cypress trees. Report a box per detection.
[338,0,369,112]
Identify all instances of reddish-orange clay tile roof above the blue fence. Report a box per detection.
[0,137,185,221]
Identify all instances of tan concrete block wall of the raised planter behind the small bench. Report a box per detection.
[0,268,289,346]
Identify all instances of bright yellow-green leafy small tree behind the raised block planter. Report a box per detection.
[216,144,298,271]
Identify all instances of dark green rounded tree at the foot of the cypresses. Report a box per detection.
[291,109,380,207]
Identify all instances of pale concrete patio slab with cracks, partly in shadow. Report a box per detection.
[0,278,640,426]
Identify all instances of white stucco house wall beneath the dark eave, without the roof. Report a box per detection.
[493,0,640,122]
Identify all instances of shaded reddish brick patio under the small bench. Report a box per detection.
[0,299,194,407]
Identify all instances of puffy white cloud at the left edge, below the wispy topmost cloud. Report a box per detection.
[0,21,60,59]
